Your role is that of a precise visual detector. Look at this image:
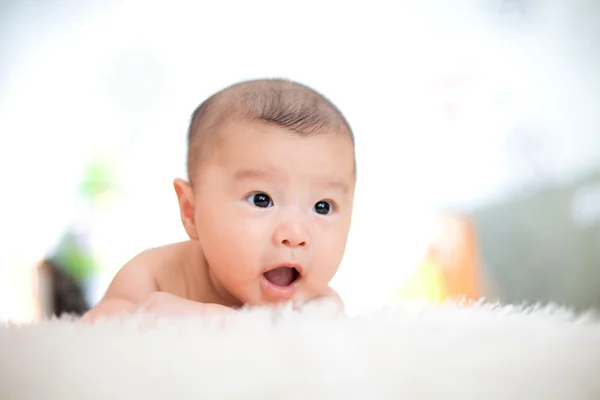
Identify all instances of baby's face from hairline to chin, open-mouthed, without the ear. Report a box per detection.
[194,122,355,305]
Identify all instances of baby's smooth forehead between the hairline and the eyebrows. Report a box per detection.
[206,121,355,183]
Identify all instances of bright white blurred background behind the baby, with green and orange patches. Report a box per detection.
[0,0,600,321]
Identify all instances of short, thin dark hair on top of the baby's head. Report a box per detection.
[187,79,354,181]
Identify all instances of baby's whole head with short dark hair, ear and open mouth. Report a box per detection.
[175,80,356,305]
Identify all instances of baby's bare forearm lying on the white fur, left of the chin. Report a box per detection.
[139,292,235,316]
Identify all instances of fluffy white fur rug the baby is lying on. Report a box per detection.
[0,303,600,400]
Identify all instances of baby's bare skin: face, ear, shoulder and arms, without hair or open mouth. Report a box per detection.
[84,121,355,320]
